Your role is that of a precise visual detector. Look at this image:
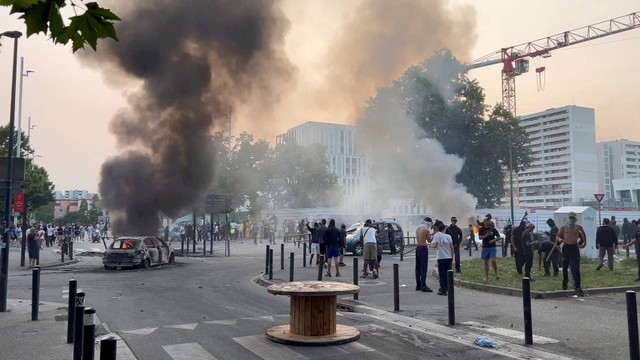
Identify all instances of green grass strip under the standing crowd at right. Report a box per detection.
[455,257,640,291]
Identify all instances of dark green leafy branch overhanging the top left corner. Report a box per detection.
[0,0,120,52]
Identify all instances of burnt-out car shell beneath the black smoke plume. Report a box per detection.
[102,236,175,270]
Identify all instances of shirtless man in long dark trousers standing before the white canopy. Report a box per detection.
[556,211,587,297]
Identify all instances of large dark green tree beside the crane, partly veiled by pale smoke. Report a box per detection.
[360,50,531,207]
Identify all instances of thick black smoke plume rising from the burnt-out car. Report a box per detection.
[84,0,293,235]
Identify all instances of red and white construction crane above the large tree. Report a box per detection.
[466,12,640,115]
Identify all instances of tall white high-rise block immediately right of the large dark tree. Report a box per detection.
[518,106,599,207]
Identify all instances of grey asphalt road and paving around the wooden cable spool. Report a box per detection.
[3,242,628,360]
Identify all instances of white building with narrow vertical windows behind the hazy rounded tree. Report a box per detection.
[276,121,366,210]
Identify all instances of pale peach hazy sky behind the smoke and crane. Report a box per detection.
[0,0,640,191]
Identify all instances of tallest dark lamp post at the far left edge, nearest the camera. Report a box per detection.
[0,31,22,312]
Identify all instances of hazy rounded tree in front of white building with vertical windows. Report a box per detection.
[265,141,343,209]
